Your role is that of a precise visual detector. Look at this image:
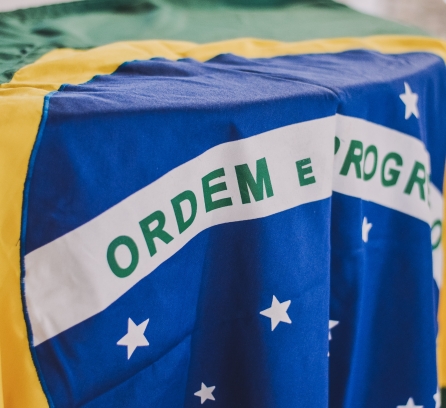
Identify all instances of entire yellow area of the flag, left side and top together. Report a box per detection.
[0,36,446,408]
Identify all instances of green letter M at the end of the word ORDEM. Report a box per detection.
[235,158,274,204]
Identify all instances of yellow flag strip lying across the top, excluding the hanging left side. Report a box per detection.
[5,36,446,91]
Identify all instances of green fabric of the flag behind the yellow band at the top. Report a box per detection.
[0,0,424,82]
